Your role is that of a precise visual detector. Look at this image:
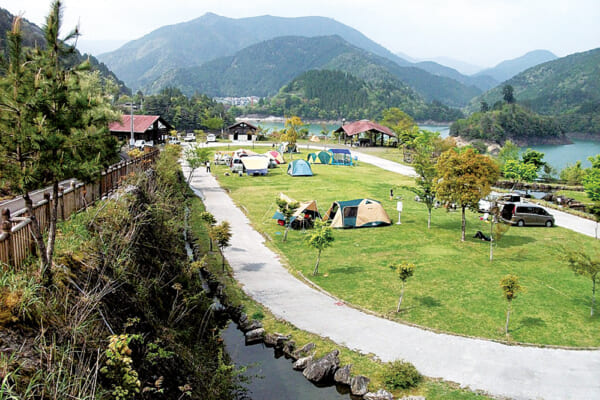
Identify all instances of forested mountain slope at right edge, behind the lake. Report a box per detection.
[470,48,600,134]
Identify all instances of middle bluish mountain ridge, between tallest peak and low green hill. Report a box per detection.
[148,36,480,106]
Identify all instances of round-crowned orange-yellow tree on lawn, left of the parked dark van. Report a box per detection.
[435,149,499,242]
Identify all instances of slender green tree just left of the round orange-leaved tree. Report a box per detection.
[407,131,442,229]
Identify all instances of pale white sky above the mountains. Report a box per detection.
[0,0,600,67]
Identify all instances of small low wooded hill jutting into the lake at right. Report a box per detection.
[450,104,569,145]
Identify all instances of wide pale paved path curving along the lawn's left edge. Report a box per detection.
[184,160,600,400]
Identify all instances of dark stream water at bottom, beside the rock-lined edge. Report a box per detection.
[221,323,350,400]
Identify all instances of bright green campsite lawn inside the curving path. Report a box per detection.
[207,147,600,347]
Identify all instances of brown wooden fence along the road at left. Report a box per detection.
[0,149,159,269]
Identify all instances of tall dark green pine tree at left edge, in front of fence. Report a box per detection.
[0,1,118,283]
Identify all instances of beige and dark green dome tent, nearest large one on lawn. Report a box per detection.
[323,199,392,228]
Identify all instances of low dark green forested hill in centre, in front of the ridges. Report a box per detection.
[245,70,462,121]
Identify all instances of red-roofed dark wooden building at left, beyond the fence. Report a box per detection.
[108,115,173,144]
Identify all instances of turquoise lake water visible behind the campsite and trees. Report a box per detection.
[241,120,600,172]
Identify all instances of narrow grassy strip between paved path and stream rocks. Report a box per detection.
[189,198,488,400]
